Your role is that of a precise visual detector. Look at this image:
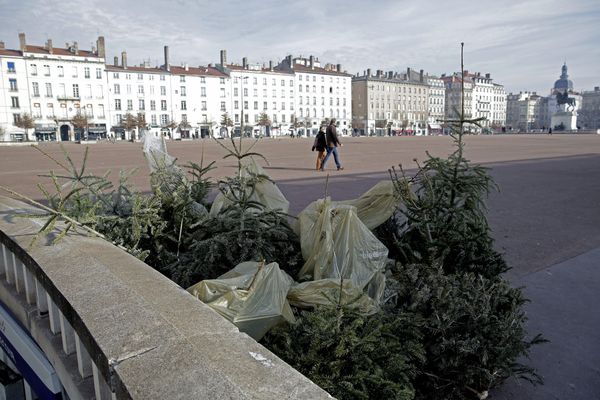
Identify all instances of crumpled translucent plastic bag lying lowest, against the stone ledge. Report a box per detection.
[188,261,295,340]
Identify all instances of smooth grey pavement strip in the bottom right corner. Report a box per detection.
[490,248,600,400]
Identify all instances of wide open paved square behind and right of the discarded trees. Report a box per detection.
[0,135,600,400]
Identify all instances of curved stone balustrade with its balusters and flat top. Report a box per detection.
[0,197,331,400]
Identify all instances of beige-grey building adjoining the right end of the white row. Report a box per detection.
[352,68,430,135]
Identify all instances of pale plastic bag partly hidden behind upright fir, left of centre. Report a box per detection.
[210,157,290,216]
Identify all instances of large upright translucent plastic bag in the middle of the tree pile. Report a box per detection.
[298,198,388,300]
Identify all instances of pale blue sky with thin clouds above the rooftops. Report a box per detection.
[0,0,600,94]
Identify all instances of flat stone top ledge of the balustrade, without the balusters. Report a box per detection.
[0,197,331,400]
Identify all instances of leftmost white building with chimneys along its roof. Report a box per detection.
[0,33,107,140]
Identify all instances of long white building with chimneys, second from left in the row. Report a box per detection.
[106,46,229,139]
